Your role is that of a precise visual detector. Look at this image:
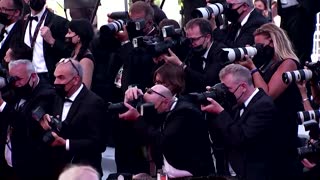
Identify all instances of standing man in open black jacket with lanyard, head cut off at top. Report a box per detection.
[23,0,71,83]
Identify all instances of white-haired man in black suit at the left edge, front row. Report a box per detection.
[0,60,56,179]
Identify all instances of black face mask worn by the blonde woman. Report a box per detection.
[252,44,274,68]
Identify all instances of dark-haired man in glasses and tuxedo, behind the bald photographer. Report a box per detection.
[163,18,227,93]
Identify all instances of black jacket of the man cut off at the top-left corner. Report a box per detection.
[0,19,23,63]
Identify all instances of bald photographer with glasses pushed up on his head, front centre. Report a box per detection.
[119,85,214,178]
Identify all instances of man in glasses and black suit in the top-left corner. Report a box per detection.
[0,0,23,64]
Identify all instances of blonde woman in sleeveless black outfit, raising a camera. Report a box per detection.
[239,23,303,177]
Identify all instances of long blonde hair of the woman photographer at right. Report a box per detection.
[253,23,299,62]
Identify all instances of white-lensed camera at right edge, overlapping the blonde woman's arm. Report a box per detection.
[282,61,320,84]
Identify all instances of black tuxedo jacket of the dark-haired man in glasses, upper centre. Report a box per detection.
[185,42,227,93]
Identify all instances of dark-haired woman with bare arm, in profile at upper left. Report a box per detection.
[65,19,94,89]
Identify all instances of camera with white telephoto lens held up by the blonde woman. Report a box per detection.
[222,44,263,63]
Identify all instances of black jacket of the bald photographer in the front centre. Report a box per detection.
[135,100,215,176]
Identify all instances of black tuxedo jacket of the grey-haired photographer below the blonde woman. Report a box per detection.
[209,89,282,180]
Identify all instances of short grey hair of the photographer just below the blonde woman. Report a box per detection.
[219,64,253,86]
